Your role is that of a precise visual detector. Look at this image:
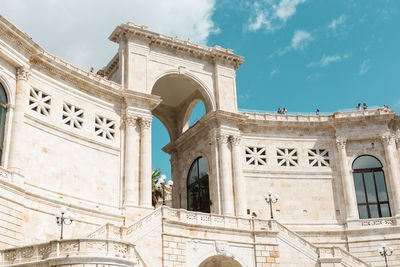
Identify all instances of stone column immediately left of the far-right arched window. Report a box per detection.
[336,138,359,220]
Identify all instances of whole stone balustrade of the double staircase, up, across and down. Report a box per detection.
[88,207,371,267]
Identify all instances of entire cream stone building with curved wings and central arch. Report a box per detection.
[0,13,400,267]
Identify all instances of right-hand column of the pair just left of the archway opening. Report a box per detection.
[139,118,152,207]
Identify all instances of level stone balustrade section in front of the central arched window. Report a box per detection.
[162,207,253,230]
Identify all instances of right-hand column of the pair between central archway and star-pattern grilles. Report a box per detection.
[230,136,247,217]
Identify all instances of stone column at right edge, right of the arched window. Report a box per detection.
[382,134,400,219]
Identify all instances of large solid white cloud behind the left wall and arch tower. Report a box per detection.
[0,0,220,70]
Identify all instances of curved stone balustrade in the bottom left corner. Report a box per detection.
[0,239,136,266]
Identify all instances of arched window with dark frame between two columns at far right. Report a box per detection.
[353,155,391,219]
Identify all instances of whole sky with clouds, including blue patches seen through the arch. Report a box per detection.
[0,0,400,180]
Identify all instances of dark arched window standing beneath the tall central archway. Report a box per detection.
[187,157,210,212]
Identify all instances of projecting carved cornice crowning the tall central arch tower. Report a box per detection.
[109,22,244,68]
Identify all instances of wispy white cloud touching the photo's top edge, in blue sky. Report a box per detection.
[248,0,307,32]
